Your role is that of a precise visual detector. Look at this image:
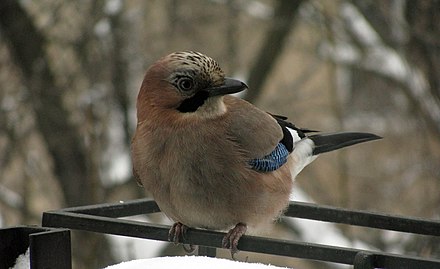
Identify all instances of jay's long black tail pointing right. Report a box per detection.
[308,133,382,155]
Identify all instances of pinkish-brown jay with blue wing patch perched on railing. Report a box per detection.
[131,51,381,256]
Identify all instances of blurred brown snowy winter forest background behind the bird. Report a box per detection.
[0,0,440,268]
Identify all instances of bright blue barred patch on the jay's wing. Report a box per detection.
[248,143,289,172]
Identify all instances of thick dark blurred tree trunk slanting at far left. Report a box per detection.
[0,0,93,206]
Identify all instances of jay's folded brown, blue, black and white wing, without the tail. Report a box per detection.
[225,96,315,172]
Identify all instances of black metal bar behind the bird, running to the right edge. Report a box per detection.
[285,202,440,236]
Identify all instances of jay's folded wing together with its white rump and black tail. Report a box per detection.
[225,96,380,175]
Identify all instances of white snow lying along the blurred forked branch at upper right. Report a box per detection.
[320,2,440,129]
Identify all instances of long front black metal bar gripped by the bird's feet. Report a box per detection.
[43,211,440,268]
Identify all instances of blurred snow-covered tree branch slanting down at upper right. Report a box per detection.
[330,3,440,134]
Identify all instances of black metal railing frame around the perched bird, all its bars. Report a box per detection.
[42,199,440,269]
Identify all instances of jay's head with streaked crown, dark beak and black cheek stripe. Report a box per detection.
[138,51,247,119]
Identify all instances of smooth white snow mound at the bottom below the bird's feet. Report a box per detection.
[105,256,286,269]
